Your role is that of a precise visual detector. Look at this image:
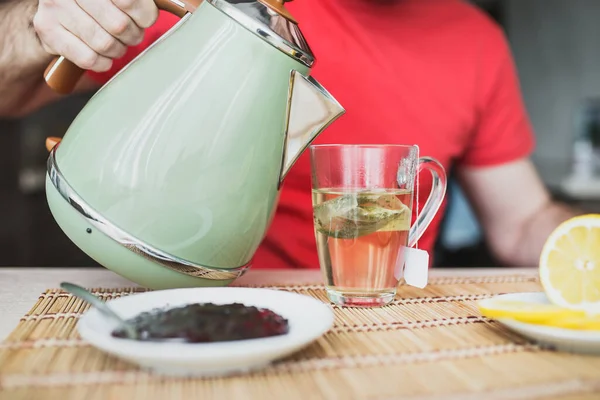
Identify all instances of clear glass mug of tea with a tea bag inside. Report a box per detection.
[310,144,446,306]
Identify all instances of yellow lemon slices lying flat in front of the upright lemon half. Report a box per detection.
[479,299,585,325]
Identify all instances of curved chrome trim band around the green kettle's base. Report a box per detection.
[47,147,251,280]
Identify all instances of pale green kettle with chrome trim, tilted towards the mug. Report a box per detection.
[45,0,344,289]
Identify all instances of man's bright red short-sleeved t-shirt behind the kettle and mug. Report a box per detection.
[85,0,534,268]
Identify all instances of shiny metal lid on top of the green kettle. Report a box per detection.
[207,0,315,68]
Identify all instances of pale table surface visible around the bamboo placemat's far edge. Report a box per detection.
[0,267,535,341]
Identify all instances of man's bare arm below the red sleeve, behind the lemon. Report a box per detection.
[458,159,580,266]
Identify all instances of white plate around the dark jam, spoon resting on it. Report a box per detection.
[78,287,334,376]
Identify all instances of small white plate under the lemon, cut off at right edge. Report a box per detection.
[479,292,600,354]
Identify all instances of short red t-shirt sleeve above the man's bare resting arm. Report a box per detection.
[460,28,535,167]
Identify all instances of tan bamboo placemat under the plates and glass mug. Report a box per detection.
[0,275,600,400]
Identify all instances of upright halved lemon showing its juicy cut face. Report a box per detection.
[539,214,600,314]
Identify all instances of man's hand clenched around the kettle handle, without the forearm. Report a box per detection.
[33,0,158,72]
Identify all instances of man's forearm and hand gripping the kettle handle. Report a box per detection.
[0,0,158,117]
